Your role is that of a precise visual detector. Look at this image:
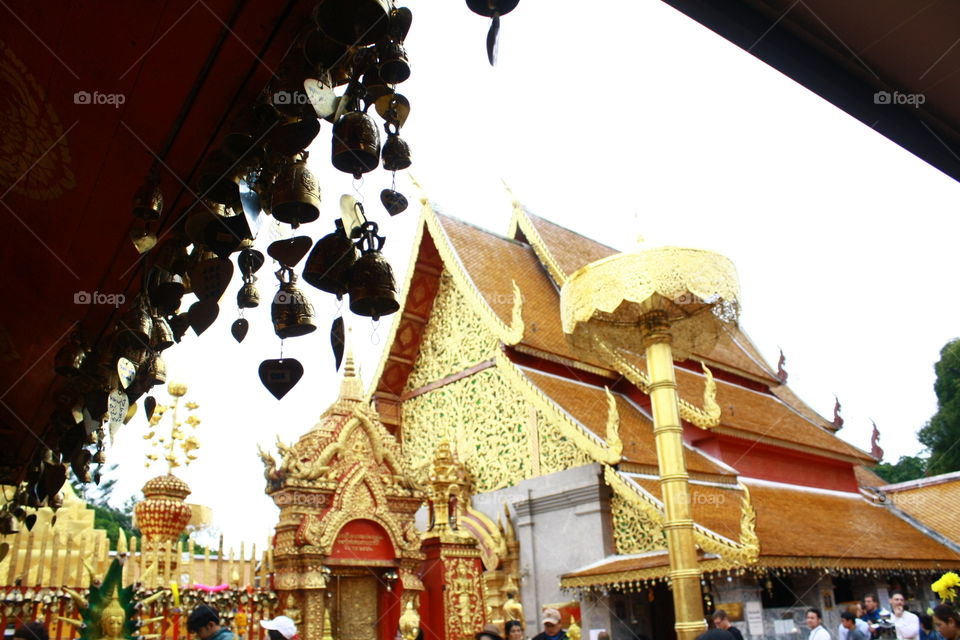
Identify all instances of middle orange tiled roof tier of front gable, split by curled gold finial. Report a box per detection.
[521,368,734,476]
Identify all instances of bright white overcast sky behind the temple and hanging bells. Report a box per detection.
[105,0,960,549]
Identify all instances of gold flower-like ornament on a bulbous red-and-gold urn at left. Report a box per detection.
[134,382,200,546]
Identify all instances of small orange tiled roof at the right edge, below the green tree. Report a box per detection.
[881,473,960,544]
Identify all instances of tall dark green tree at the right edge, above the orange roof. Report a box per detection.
[917,339,960,475]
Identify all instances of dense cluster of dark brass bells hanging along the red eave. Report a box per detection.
[0,0,420,534]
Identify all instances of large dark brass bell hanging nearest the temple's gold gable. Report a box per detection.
[349,221,400,320]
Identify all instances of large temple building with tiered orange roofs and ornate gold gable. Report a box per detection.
[360,202,960,638]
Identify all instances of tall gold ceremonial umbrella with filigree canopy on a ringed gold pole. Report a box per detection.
[560,247,740,640]
